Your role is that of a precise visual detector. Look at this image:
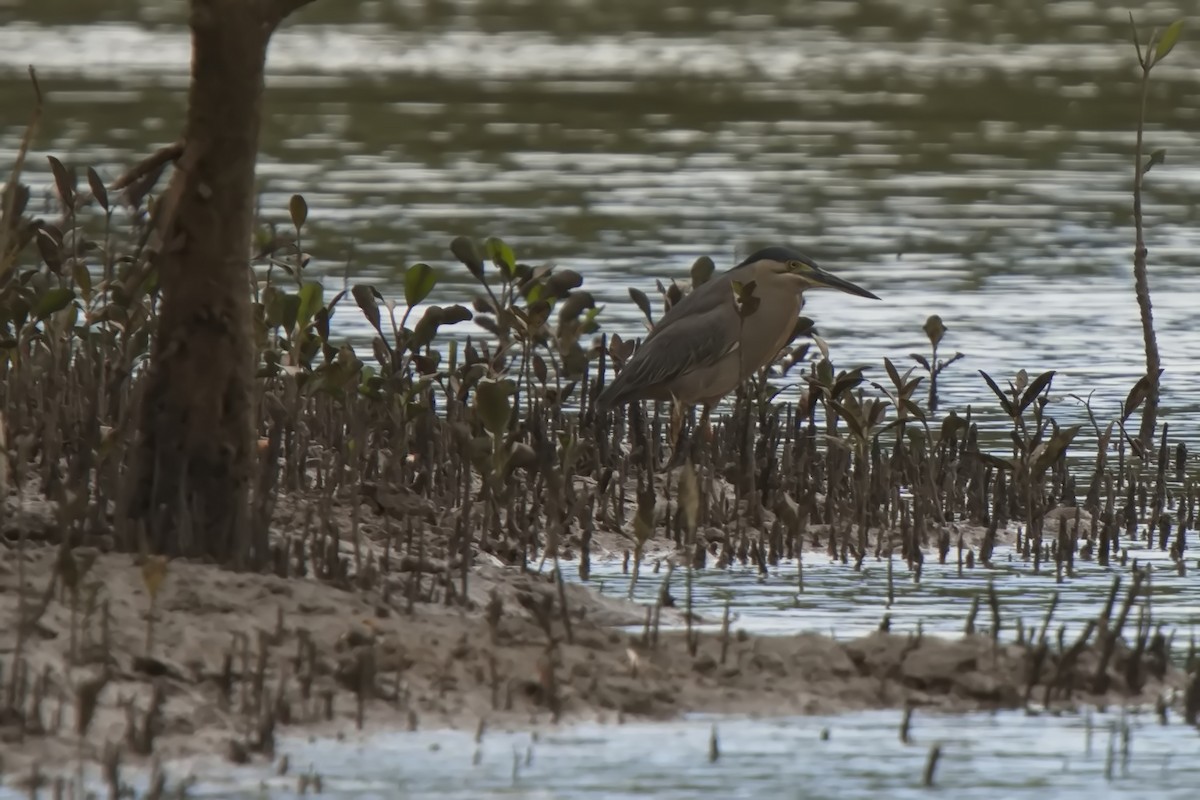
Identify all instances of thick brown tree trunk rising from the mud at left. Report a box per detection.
[130,0,319,569]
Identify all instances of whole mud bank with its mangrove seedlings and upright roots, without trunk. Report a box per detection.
[0,6,1200,796]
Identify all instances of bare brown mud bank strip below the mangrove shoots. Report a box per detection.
[0,491,1184,786]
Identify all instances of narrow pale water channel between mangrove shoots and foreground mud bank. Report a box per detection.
[562,545,1200,642]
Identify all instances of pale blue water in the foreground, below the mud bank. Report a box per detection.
[35,710,1200,800]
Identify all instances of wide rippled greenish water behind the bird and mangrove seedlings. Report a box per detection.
[0,0,1200,441]
